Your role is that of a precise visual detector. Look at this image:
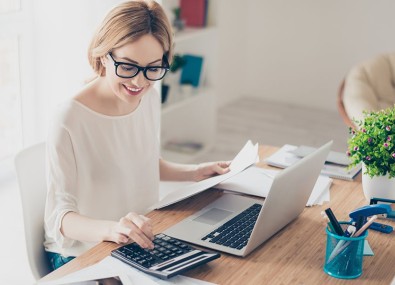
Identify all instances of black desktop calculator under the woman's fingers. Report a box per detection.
[111,233,220,279]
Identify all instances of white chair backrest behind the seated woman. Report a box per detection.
[15,143,50,280]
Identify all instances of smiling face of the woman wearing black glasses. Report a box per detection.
[105,34,164,104]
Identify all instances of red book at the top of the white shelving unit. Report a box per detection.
[180,0,208,27]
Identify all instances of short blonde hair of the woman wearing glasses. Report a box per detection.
[88,0,173,76]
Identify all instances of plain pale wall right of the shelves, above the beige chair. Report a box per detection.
[219,0,395,110]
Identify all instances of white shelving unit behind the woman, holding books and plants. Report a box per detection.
[159,0,218,163]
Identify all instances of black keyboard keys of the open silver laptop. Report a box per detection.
[202,204,262,249]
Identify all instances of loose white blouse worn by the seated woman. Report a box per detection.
[44,88,160,256]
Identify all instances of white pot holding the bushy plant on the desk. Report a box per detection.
[362,164,395,202]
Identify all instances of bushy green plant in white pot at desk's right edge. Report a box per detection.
[347,107,395,200]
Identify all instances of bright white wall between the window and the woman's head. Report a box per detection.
[29,0,121,145]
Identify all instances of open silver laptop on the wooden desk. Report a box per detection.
[164,141,333,256]
